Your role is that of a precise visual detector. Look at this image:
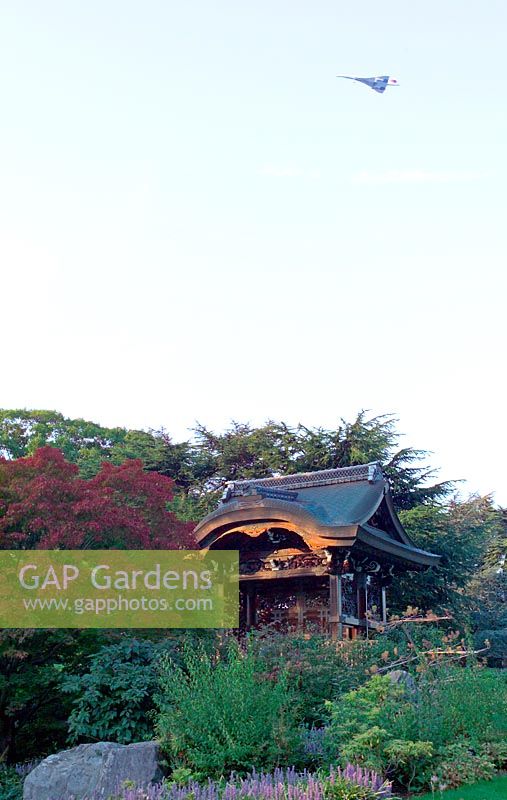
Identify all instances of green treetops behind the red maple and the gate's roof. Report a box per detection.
[0,409,451,520]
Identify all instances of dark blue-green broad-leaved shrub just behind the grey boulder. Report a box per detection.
[62,638,179,744]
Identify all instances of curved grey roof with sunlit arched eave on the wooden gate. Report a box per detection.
[195,463,440,577]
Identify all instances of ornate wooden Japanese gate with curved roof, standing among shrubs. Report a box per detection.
[195,462,439,638]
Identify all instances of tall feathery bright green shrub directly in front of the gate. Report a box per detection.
[157,642,301,777]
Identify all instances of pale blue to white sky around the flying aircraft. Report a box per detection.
[0,0,507,504]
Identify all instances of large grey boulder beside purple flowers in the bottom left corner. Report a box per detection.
[23,742,162,800]
